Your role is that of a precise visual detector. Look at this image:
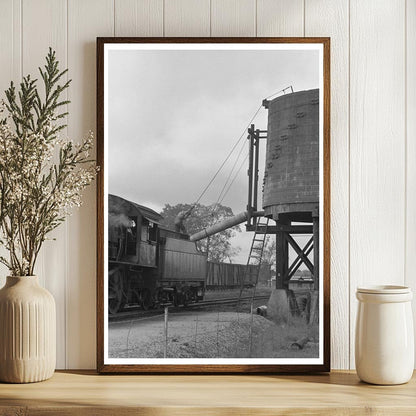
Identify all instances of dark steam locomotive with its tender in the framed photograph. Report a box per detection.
[108,194,207,314]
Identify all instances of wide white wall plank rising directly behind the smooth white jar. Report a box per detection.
[350,0,405,368]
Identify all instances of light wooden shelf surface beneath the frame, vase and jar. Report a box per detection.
[0,371,416,416]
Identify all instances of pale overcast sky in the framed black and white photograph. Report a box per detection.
[108,50,319,263]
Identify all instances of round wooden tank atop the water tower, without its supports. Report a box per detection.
[263,89,319,221]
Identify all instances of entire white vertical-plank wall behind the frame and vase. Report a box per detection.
[0,0,416,369]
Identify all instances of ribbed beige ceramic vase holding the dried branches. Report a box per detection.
[0,276,56,383]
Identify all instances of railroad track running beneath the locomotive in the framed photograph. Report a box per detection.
[108,295,270,322]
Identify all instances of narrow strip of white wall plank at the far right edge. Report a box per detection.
[405,0,416,364]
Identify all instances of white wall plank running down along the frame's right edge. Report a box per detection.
[305,0,349,369]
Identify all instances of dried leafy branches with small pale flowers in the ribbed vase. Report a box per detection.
[0,48,97,276]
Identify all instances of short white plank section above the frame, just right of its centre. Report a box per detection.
[211,0,256,37]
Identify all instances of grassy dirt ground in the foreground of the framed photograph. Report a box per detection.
[109,311,319,358]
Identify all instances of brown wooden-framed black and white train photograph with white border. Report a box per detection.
[97,38,330,373]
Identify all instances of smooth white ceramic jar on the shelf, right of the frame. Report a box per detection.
[355,286,414,384]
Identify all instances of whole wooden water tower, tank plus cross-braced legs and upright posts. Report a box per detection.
[247,89,319,290]
